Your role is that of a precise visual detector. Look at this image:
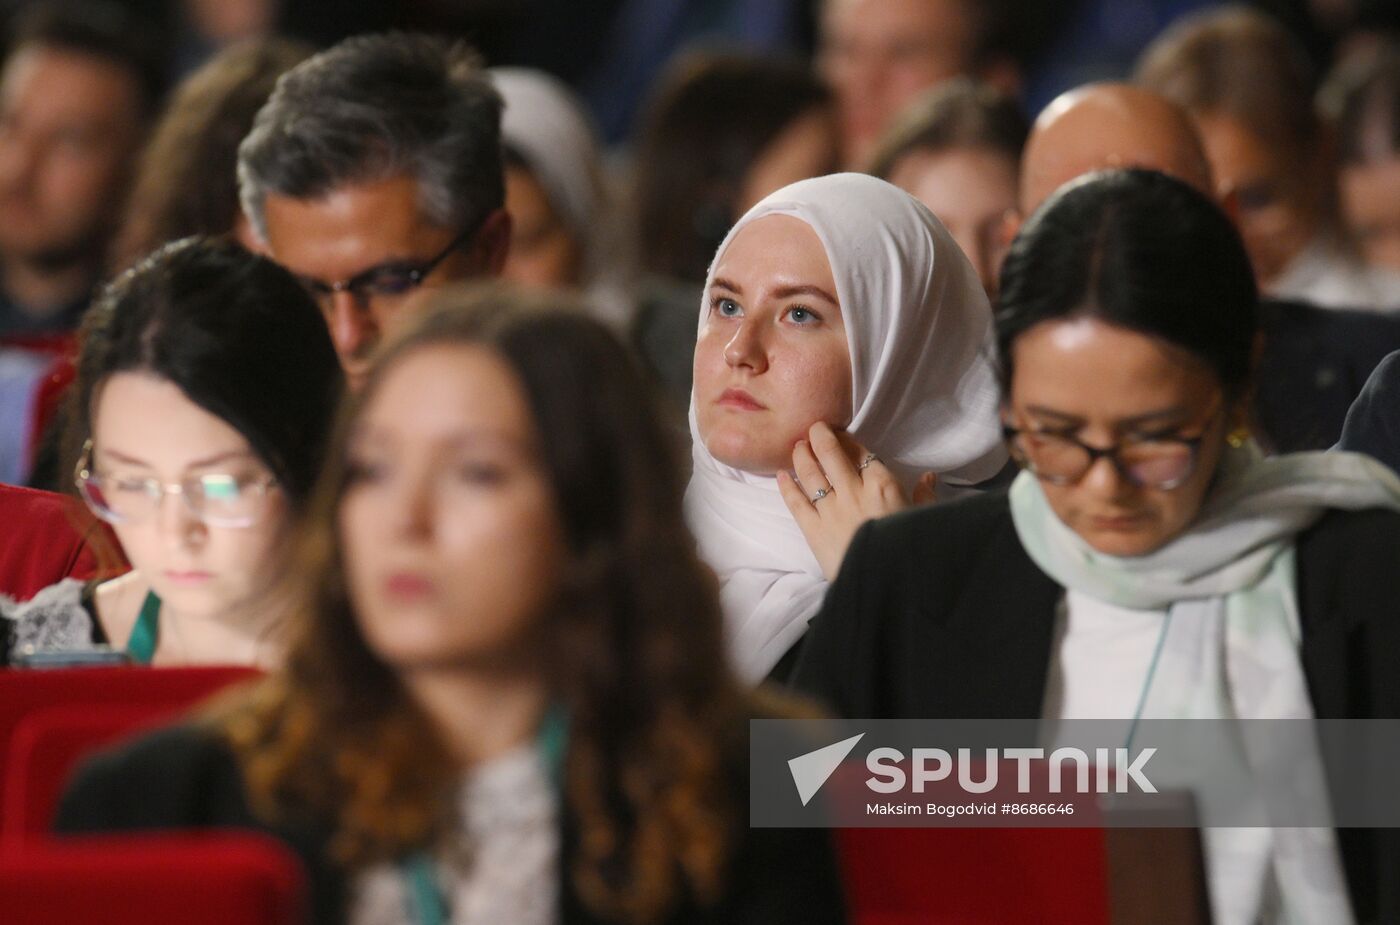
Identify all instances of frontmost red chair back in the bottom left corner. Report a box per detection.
[0,833,305,925]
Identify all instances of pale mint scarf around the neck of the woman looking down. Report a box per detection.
[1011,446,1400,924]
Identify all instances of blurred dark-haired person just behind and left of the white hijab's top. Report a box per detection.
[633,53,839,411]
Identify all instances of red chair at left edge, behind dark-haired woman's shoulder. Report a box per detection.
[0,484,126,600]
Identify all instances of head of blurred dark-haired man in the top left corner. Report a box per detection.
[0,0,162,337]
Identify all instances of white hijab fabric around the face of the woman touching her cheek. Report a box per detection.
[686,174,1007,682]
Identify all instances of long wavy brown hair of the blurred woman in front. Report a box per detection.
[217,288,749,922]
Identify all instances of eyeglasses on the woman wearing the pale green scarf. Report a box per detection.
[1001,403,1215,491]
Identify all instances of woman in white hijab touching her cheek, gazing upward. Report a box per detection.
[686,174,1007,682]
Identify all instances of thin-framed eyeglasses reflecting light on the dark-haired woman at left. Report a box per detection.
[73,439,277,528]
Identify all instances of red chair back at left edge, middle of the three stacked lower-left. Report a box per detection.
[0,704,169,844]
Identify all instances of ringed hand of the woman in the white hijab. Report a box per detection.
[777,423,935,581]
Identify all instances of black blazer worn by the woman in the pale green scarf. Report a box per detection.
[792,493,1400,922]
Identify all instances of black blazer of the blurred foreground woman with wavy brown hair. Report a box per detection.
[56,726,846,925]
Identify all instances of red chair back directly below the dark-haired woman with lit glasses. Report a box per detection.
[0,666,260,778]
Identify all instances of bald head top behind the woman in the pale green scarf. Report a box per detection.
[1021,84,1214,216]
